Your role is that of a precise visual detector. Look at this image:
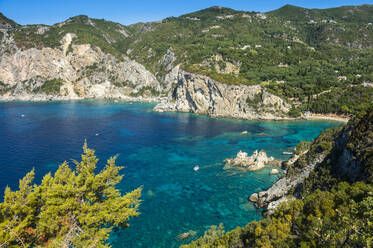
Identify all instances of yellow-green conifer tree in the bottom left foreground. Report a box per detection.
[0,143,141,248]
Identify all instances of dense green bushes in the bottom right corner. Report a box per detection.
[181,182,373,248]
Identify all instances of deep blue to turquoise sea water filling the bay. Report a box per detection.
[0,101,339,248]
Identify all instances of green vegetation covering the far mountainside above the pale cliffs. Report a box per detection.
[0,5,373,117]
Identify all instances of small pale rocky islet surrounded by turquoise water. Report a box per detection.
[224,150,275,171]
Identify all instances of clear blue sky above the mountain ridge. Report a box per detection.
[0,0,373,24]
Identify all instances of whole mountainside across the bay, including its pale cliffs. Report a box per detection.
[0,5,373,119]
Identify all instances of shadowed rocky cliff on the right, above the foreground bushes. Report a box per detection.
[256,108,373,213]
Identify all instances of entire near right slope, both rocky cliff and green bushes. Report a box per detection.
[181,108,373,248]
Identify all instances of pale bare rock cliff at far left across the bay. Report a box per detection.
[0,33,162,100]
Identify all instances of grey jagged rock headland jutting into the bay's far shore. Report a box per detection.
[155,67,290,120]
